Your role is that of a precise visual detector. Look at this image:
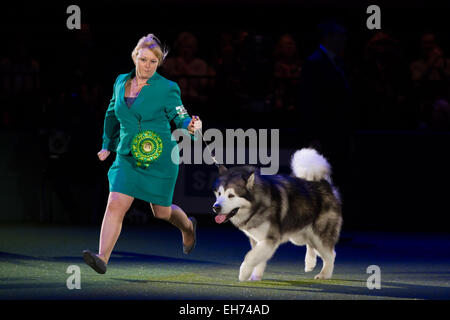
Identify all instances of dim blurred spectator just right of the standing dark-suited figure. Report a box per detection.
[357,31,415,129]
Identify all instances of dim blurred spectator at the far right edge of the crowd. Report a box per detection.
[410,32,450,129]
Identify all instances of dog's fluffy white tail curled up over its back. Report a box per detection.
[291,148,331,184]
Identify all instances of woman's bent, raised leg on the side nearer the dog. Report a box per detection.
[150,203,194,246]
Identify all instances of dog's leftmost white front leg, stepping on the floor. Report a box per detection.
[239,240,278,281]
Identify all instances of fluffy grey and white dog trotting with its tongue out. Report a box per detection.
[213,148,343,281]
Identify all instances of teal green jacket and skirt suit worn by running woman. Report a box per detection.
[102,70,197,206]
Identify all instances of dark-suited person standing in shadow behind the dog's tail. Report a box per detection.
[298,19,352,201]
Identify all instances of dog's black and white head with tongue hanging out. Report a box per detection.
[212,165,258,223]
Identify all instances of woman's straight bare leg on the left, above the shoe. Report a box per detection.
[97,192,134,263]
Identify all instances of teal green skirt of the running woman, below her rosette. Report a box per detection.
[108,152,178,207]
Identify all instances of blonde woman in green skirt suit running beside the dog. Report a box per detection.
[83,34,202,273]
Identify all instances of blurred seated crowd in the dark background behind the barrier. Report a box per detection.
[0,24,450,136]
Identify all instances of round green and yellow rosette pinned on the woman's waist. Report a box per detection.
[131,130,163,168]
